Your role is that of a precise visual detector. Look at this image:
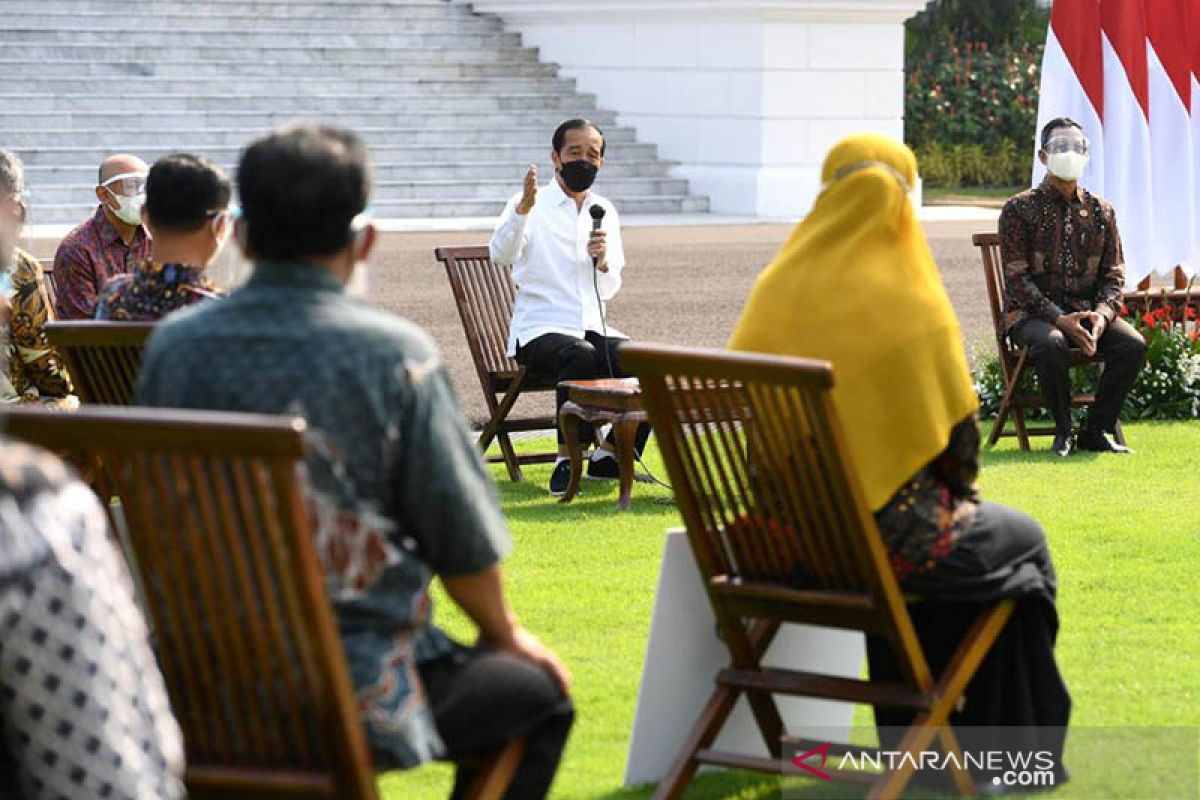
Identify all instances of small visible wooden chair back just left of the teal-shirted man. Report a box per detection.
[46,320,155,405]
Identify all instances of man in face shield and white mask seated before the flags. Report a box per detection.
[1000,118,1146,456]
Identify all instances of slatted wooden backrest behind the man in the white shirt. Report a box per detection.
[434,246,521,390]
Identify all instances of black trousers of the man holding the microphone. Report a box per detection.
[517,331,650,453]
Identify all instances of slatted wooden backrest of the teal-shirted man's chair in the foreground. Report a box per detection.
[0,408,377,800]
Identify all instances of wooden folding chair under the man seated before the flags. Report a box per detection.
[971,233,1126,450]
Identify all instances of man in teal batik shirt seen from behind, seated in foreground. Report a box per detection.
[137,126,574,799]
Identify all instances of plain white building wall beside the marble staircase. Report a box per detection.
[470,0,925,218]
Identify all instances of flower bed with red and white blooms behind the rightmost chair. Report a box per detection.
[973,299,1200,420]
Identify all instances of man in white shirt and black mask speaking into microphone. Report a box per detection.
[488,119,649,497]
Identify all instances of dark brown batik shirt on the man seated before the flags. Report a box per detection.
[1000,179,1124,330]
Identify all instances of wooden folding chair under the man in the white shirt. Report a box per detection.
[433,247,558,482]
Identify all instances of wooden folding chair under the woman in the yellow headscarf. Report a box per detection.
[622,344,1013,799]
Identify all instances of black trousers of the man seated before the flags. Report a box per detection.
[1010,317,1146,433]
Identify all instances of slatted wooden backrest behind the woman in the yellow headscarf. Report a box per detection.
[622,344,908,630]
